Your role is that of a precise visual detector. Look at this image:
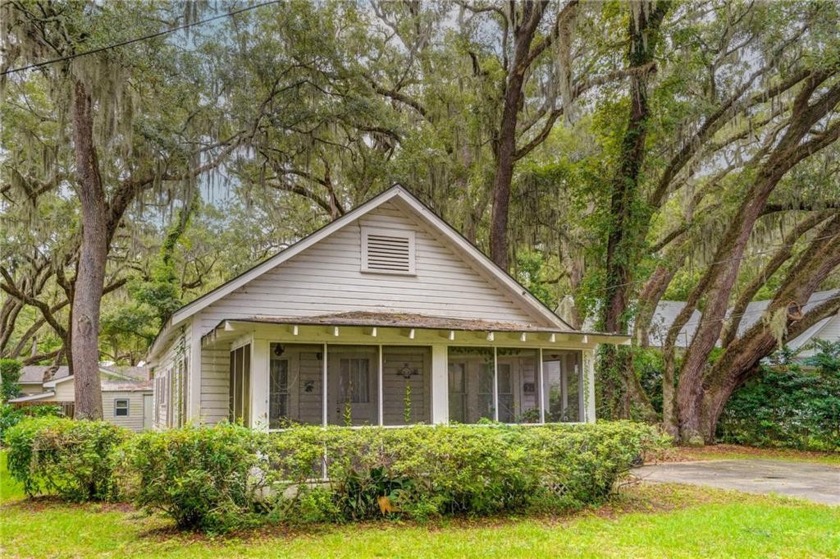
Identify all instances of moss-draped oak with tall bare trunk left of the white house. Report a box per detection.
[2,1,238,419]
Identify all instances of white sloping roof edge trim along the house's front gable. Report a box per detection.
[150,184,576,355]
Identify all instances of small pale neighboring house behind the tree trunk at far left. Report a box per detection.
[9,366,153,431]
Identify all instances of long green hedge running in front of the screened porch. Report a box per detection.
[118,422,659,532]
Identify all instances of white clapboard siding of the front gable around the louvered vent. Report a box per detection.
[194,201,546,340]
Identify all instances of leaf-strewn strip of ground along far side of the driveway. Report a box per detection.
[656,444,840,467]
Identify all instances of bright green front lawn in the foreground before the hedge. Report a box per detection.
[0,448,840,559]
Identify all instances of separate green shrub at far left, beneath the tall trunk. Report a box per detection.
[5,417,131,502]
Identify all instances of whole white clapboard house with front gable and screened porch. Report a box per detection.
[150,186,629,430]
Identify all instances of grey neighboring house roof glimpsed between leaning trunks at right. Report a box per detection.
[650,289,840,358]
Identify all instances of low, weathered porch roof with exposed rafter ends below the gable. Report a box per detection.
[204,311,630,344]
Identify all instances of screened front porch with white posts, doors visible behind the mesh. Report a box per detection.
[228,342,586,430]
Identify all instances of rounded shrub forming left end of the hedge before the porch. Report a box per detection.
[115,423,267,533]
